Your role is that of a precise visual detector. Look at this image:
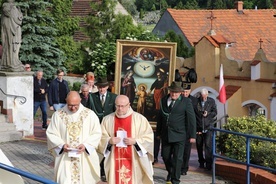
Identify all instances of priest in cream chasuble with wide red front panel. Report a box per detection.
[99,95,153,184]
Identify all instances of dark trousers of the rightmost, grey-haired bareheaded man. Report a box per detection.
[196,131,213,168]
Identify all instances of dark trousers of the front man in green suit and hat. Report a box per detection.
[161,141,185,184]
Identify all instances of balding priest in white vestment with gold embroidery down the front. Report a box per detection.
[46,91,102,184]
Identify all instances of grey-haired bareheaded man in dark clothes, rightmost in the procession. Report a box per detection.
[196,88,217,170]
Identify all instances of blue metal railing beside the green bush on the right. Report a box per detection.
[212,128,276,184]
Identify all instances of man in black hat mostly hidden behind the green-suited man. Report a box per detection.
[181,82,198,175]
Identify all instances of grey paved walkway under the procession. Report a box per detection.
[0,122,231,184]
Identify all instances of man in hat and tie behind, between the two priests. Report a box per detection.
[89,78,117,181]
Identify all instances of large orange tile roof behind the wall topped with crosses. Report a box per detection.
[167,9,276,62]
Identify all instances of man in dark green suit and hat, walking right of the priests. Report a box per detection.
[156,82,196,184]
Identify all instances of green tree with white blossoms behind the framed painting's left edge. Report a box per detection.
[83,0,147,77]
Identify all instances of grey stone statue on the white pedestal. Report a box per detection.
[0,0,24,72]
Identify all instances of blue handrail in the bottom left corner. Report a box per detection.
[0,162,57,184]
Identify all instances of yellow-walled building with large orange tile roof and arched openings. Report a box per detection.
[153,1,276,123]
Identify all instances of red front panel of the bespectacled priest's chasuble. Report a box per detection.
[114,115,132,184]
